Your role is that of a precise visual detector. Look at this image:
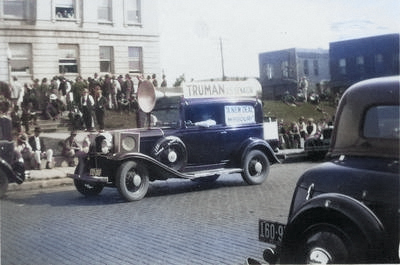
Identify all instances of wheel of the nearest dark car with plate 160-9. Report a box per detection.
[280,223,364,264]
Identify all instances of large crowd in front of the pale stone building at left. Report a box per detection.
[0,73,167,169]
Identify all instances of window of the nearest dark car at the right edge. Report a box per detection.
[363,106,400,139]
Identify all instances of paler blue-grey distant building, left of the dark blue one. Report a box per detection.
[259,48,330,99]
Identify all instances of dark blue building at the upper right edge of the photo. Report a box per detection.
[329,34,399,92]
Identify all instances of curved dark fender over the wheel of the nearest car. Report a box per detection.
[282,193,385,255]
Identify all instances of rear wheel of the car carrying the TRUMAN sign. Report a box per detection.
[242,150,269,185]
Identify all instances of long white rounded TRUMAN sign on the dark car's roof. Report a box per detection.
[182,79,261,98]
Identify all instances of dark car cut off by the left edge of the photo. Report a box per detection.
[0,99,29,198]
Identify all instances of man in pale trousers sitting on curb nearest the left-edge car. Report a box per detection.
[28,127,53,169]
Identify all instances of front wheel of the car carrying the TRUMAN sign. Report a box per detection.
[115,161,150,201]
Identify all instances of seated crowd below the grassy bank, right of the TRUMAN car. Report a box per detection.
[278,117,333,149]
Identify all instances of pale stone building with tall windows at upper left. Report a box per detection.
[0,0,161,83]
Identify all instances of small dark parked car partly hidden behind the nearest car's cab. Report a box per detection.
[304,126,333,160]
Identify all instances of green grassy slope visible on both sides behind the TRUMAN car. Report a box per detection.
[105,100,336,130]
